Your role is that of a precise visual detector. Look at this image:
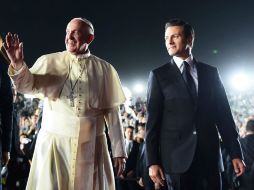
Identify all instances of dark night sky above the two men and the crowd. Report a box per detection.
[0,0,254,94]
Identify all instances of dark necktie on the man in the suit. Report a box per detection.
[182,61,198,104]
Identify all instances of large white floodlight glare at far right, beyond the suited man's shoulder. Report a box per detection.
[231,72,252,91]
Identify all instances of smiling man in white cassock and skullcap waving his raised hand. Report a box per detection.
[4,18,126,190]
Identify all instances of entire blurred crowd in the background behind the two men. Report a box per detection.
[2,91,254,190]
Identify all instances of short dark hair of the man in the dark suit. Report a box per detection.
[165,18,195,39]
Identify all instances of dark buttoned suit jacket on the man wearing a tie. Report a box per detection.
[146,60,242,173]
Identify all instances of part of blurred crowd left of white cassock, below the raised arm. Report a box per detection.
[2,91,42,190]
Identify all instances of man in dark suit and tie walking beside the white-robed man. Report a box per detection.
[146,19,244,190]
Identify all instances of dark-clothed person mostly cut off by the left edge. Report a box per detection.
[0,36,13,190]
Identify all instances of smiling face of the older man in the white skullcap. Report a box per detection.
[65,19,88,55]
